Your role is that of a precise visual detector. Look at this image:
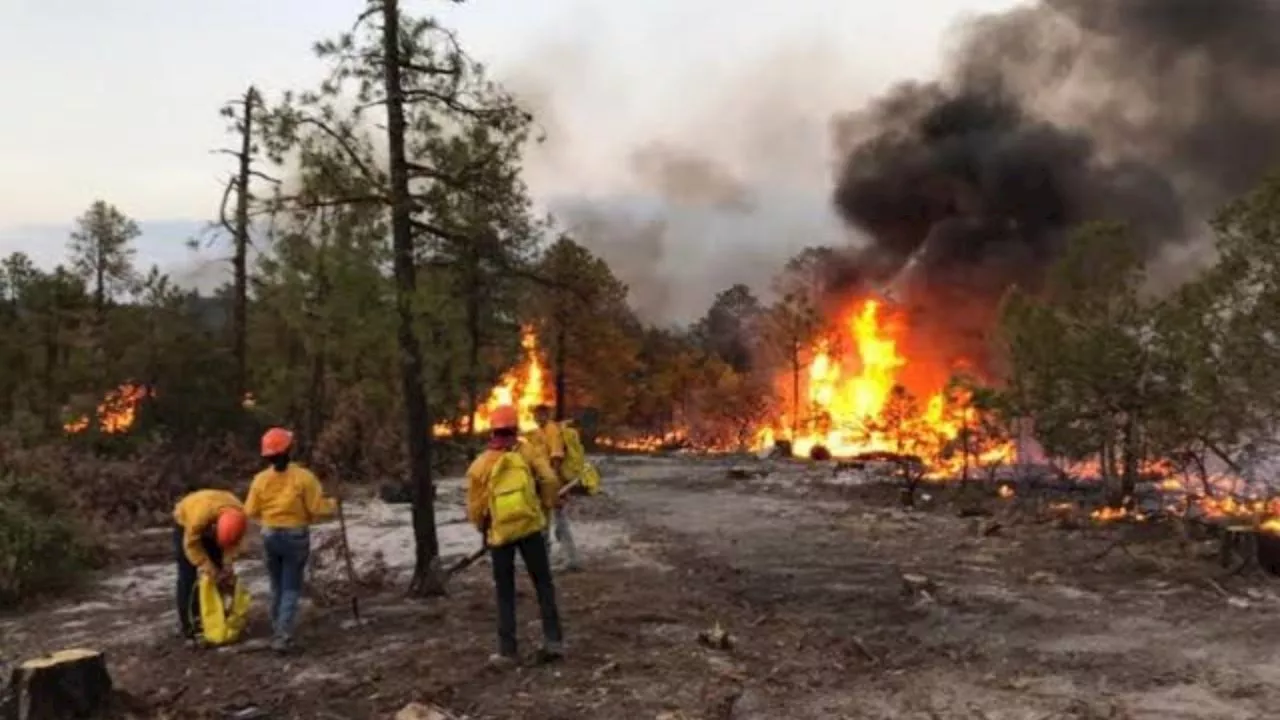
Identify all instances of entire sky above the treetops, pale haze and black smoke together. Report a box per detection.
[0,0,1280,322]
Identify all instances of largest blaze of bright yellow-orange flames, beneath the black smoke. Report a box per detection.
[756,300,1012,475]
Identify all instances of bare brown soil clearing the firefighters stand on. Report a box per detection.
[0,457,1280,720]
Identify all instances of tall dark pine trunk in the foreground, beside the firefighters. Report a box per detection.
[381,0,444,596]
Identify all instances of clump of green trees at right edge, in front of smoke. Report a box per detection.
[987,178,1280,496]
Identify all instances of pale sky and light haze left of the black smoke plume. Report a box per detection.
[0,0,1009,313]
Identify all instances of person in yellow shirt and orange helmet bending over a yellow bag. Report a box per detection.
[173,489,246,641]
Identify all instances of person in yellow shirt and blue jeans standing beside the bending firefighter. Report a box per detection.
[244,428,337,652]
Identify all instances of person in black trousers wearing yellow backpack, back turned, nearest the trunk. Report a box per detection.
[467,405,563,669]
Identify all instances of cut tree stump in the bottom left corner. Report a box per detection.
[4,650,111,720]
